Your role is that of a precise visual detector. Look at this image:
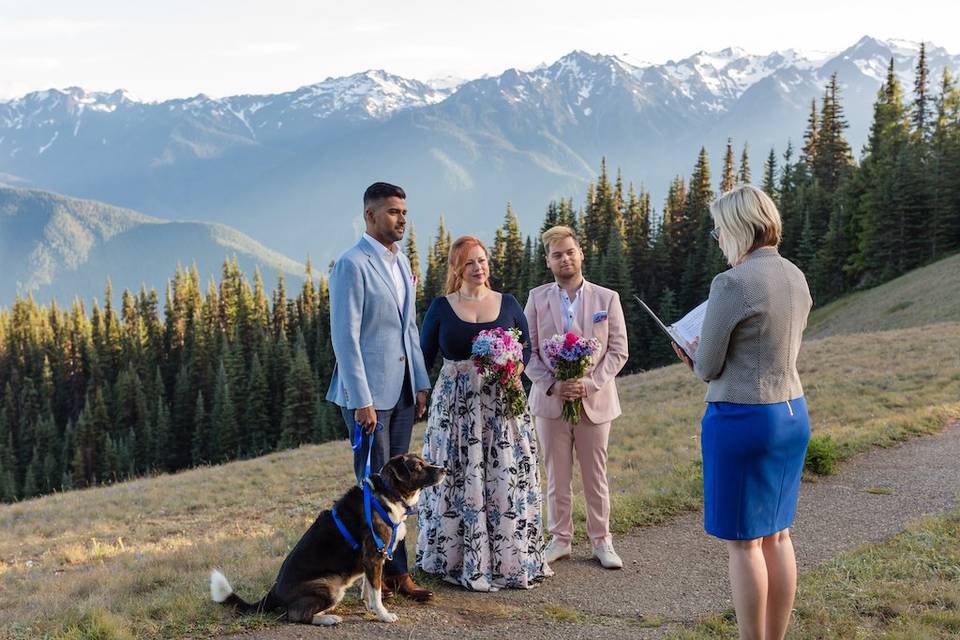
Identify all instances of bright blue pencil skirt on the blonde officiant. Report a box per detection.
[700,397,810,540]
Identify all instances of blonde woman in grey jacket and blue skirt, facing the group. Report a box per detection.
[674,185,813,640]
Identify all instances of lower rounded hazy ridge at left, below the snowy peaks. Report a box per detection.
[0,187,305,306]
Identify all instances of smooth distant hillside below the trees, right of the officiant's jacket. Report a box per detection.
[806,255,960,338]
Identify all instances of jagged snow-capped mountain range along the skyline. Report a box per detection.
[0,37,960,263]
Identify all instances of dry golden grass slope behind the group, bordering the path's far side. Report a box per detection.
[0,322,960,638]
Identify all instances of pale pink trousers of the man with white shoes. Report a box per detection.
[534,414,610,545]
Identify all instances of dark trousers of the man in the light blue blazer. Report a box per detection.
[340,369,415,576]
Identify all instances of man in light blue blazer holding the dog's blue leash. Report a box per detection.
[327,182,433,601]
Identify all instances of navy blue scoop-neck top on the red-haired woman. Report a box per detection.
[420,293,530,369]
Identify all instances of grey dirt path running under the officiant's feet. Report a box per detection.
[231,424,960,640]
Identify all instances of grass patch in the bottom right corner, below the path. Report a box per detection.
[668,510,960,640]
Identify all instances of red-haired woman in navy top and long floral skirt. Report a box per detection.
[417,236,551,591]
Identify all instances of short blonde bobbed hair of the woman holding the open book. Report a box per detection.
[710,184,783,266]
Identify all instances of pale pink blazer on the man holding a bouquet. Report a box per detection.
[524,281,627,424]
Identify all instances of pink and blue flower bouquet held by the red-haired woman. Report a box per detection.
[471,327,527,418]
